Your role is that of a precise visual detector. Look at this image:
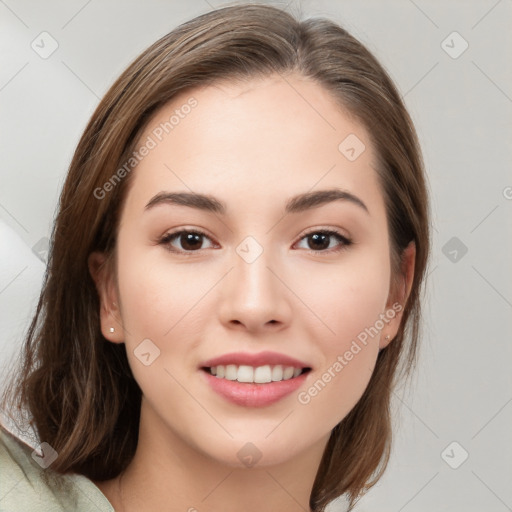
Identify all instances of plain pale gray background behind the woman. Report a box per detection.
[0,0,512,512]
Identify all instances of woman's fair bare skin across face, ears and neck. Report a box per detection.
[89,75,415,512]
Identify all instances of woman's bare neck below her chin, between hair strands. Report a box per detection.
[96,400,328,512]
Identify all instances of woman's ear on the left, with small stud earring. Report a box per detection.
[88,252,124,343]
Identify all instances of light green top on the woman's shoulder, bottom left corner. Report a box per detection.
[0,426,115,512]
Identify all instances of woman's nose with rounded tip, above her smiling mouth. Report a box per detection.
[218,245,293,334]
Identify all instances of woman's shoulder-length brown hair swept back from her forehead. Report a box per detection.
[2,4,430,512]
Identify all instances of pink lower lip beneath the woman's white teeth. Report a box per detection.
[201,370,311,407]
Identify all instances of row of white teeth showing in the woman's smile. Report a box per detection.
[209,364,302,384]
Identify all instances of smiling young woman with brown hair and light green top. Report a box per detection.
[0,5,429,512]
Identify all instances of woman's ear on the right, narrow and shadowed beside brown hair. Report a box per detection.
[379,241,416,349]
